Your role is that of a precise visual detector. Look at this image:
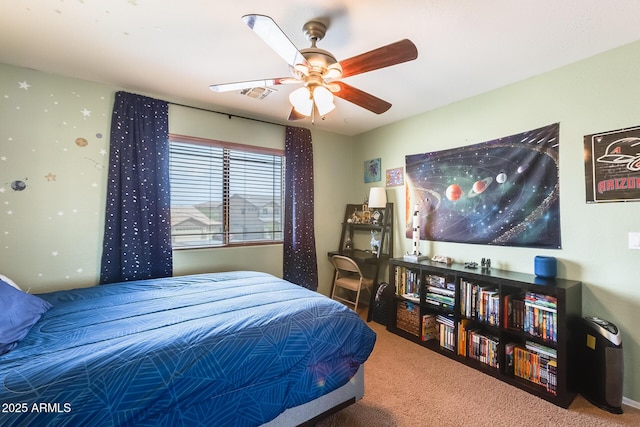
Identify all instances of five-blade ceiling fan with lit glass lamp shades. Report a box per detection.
[210,15,418,120]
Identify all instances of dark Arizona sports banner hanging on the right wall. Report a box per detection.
[584,127,640,203]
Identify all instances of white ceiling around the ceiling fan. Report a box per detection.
[0,0,640,135]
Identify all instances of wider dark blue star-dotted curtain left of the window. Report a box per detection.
[100,92,173,283]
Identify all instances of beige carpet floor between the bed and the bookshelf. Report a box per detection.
[317,322,640,427]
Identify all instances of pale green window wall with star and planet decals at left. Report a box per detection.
[0,64,352,294]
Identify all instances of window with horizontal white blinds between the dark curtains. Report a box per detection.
[169,134,284,249]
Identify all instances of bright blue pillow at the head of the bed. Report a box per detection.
[0,280,51,354]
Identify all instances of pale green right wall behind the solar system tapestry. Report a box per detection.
[353,43,640,402]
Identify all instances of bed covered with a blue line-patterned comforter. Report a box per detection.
[0,272,376,426]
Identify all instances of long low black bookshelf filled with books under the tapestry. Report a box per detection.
[387,258,582,408]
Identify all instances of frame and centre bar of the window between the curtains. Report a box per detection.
[169,133,286,251]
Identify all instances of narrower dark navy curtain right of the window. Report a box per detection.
[283,126,318,291]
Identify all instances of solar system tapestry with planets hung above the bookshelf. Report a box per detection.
[405,123,561,249]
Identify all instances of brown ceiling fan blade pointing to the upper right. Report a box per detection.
[340,39,418,78]
